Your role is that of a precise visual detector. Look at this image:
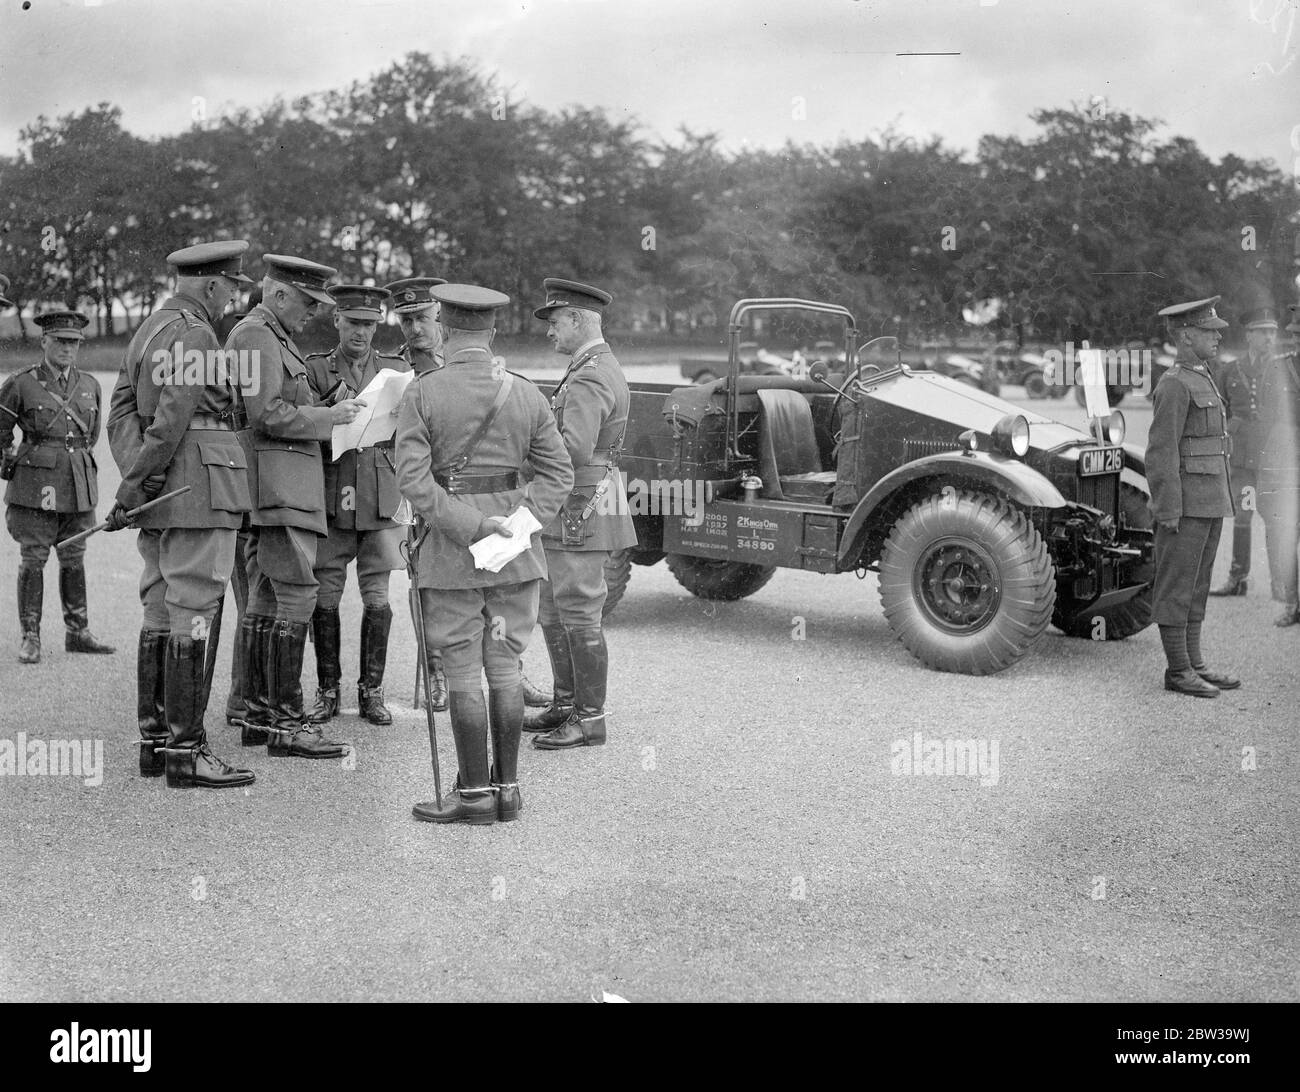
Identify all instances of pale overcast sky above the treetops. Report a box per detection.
[0,0,1300,170]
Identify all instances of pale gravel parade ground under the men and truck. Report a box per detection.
[0,365,1300,1001]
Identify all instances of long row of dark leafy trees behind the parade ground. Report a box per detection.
[0,53,1300,341]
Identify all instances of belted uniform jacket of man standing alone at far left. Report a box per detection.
[0,361,103,512]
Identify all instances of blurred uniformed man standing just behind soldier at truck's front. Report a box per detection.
[1210,307,1278,595]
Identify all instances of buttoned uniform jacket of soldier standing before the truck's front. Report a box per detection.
[1147,360,1236,520]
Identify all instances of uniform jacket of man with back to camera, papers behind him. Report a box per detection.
[397,350,573,588]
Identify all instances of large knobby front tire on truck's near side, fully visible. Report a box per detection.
[880,490,1056,675]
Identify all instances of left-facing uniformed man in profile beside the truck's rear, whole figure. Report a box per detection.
[525,277,637,750]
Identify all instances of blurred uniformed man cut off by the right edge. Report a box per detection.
[1258,304,1300,627]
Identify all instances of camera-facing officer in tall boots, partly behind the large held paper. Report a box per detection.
[307,285,411,724]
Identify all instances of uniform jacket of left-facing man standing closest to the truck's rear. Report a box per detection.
[542,342,637,551]
